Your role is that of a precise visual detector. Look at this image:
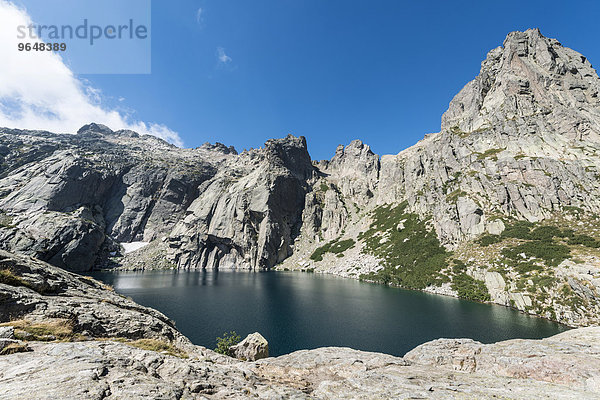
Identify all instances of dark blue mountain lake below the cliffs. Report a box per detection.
[94,271,566,356]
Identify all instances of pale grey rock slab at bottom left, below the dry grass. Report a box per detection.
[0,341,307,400]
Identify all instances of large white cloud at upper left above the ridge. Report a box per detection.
[0,0,183,146]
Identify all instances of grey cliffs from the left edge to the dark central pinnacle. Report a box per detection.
[0,124,314,271]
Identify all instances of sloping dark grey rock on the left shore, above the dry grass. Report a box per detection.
[0,250,191,347]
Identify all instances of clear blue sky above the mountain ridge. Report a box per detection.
[5,0,600,159]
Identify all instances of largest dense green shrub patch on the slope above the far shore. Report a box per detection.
[359,202,450,289]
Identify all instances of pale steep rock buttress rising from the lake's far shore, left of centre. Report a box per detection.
[167,135,315,269]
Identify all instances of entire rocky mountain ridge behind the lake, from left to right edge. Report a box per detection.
[0,29,600,325]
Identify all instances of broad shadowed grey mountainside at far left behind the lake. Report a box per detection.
[0,124,218,271]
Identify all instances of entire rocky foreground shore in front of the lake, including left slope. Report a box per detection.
[0,252,600,399]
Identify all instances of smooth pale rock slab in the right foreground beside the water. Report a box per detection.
[404,327,600,395]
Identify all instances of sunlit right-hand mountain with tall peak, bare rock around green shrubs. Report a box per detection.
[281,29,600,326]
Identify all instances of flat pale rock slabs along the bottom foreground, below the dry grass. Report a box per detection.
[0,331,600,400]
